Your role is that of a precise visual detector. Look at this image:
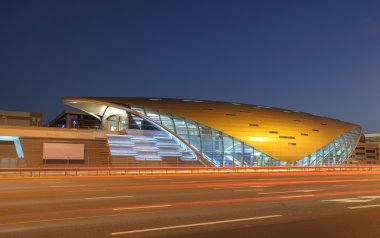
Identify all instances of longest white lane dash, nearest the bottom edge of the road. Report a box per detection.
[111,215,282,236]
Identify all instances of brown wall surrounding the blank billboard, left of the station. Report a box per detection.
[0,125,109,167]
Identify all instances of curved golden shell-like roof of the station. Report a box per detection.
[64,98,360,162]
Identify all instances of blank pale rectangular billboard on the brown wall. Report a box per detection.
[43,143,84,160]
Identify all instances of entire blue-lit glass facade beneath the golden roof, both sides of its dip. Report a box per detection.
[131,107,361,167]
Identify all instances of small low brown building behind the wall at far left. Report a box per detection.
[0,110,42,126]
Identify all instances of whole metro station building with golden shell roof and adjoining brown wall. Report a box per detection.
[0,98,362,167]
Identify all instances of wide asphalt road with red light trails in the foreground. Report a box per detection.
[0,172,380,238]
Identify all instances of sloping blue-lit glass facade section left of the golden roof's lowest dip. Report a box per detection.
[131,107,274,167]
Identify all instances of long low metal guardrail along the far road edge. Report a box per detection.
[0,165,380,177]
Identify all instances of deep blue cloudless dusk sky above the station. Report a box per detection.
[0,0,380,133]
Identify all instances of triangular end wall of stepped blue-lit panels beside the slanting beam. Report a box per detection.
[104,113,197,163]
